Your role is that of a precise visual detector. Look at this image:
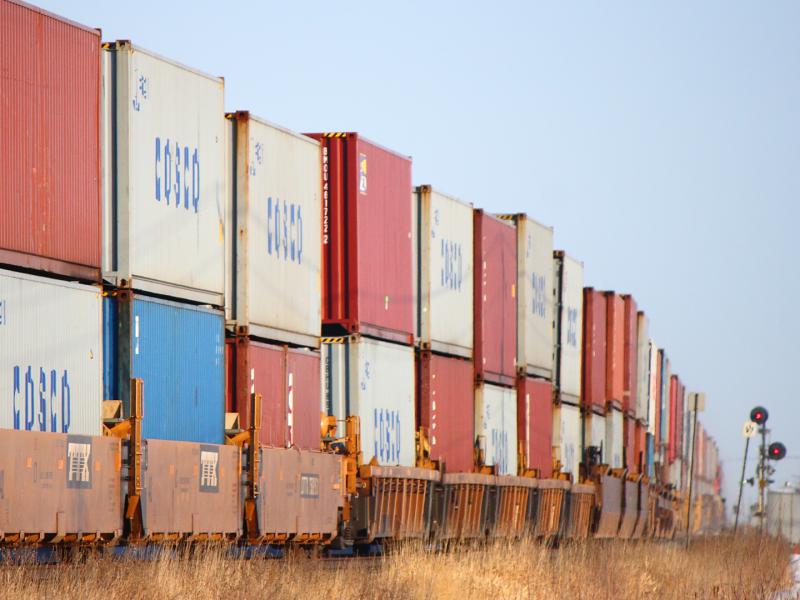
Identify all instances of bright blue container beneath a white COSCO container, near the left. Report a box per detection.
[103,292,225,444]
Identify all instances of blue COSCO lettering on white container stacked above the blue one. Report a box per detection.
[154,136,200,213]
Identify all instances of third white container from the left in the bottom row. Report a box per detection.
[475,383,517,475]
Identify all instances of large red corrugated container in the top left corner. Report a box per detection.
[0,0,102,281]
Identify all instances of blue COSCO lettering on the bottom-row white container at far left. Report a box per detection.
[13,365,72,433]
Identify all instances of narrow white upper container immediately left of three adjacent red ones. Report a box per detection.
[553,250,583,404]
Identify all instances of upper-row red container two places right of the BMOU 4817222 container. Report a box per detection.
[473,209,517,385]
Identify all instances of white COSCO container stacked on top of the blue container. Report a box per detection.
[104,41,229,306]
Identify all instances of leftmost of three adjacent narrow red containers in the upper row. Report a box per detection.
[581,288,606,414]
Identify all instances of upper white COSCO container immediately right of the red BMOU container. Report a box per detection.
[413,185,474,358]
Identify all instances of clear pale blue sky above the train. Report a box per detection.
[39,0,800,506]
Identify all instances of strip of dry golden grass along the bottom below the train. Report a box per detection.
[0,536,790,600]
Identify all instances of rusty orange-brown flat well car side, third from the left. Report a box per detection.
[258,447,344,542]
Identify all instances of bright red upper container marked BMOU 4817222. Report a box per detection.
[307,133,414,344]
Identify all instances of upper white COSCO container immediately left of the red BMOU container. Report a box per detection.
[227,111,322,347]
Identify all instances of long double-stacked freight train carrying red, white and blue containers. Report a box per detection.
[0,0,724,553]
